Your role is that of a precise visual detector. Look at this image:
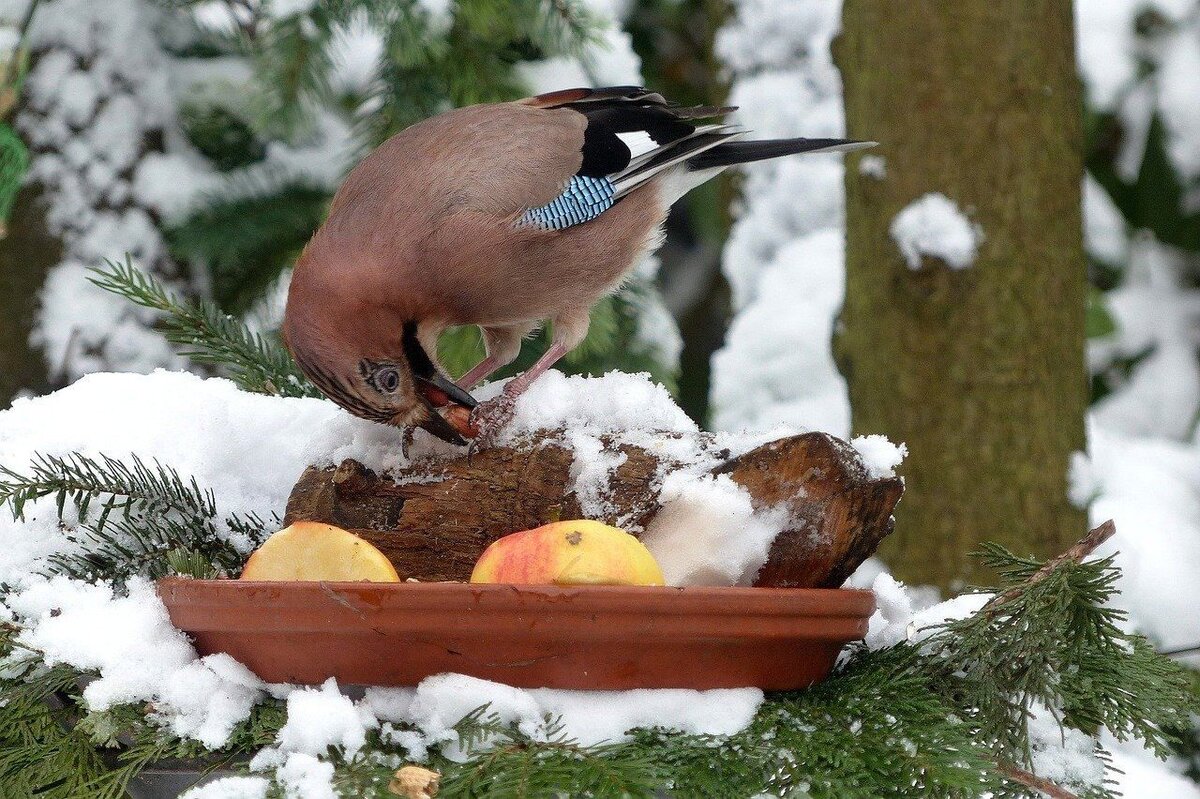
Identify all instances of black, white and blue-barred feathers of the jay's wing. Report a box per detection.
[517,86,743,230]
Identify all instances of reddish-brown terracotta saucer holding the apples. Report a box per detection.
[158,577,875,690]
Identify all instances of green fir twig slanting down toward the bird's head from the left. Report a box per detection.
[90,256,322,397]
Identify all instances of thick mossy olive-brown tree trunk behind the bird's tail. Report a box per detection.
[835,0,1087,587]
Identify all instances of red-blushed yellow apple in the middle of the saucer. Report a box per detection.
[470,519,662,585]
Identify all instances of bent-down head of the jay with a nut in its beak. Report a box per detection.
[283,307,476,444]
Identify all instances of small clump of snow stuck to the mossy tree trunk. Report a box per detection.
[888,192,983,270]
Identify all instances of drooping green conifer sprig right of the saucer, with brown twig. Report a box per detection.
[926,523,1193,765]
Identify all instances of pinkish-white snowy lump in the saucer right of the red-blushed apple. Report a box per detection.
[641,471,788,585]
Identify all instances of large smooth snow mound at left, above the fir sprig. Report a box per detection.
[0,372,408,582]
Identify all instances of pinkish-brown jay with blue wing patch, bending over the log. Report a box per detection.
[283,86,871,444]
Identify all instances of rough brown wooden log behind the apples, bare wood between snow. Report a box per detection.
[284,432,904,587]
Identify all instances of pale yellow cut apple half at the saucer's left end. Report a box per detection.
[241,522,400,583]
